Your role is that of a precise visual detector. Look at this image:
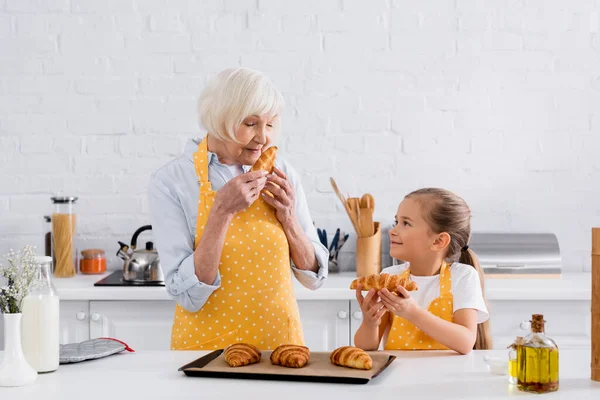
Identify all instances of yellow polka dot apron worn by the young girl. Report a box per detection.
[384,262,453,350]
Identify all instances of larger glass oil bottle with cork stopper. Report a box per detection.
[517,314,558,393]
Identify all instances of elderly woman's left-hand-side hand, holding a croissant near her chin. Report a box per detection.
[215,171,267,215]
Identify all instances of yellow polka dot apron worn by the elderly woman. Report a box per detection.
[171,138,304,350]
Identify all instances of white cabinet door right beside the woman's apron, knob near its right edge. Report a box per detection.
[298,300,350,351]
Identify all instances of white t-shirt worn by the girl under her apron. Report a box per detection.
[381,262,490,324]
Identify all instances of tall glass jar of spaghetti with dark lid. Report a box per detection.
[51,197,77,278]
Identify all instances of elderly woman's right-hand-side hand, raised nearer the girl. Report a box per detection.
[261,167,296,229]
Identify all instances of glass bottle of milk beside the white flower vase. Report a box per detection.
[21,257,60,372]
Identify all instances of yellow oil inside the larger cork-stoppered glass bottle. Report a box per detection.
[517,345,558,393]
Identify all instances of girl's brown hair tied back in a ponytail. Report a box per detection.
[406,188,492,350]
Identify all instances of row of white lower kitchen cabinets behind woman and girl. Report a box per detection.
[51,299,591,351]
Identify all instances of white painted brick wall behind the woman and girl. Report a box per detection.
[0,0,600,270]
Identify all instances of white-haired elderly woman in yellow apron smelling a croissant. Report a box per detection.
[148,68,329,350]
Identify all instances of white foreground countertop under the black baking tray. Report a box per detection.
[0,349,600,400]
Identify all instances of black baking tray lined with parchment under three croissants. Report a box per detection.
[179,350,396,384]
